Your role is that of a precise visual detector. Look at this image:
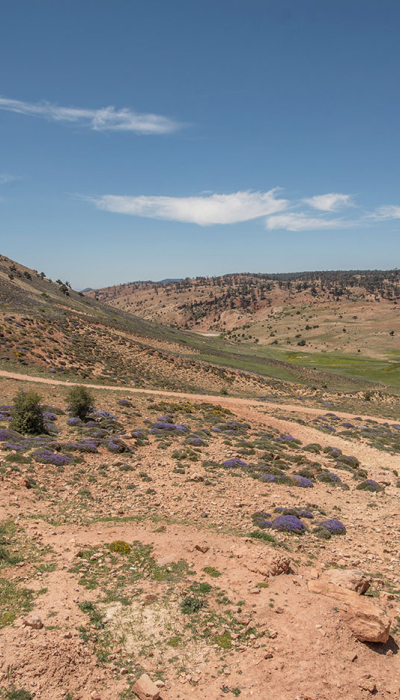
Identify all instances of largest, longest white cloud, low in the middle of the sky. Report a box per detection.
[92,188,287,226]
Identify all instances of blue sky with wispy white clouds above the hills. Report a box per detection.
[0,0,400,289]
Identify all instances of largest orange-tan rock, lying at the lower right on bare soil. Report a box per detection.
[308,579,390,643]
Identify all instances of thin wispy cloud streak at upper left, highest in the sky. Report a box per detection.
[0,97,182,134]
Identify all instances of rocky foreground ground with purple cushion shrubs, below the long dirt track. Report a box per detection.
[0,378,400,700]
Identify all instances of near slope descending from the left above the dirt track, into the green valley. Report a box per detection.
[0,257,400,400]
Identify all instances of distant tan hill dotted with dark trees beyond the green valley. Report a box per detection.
[88,270,400,358]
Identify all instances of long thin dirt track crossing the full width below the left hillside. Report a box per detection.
[0,370,395,423]
